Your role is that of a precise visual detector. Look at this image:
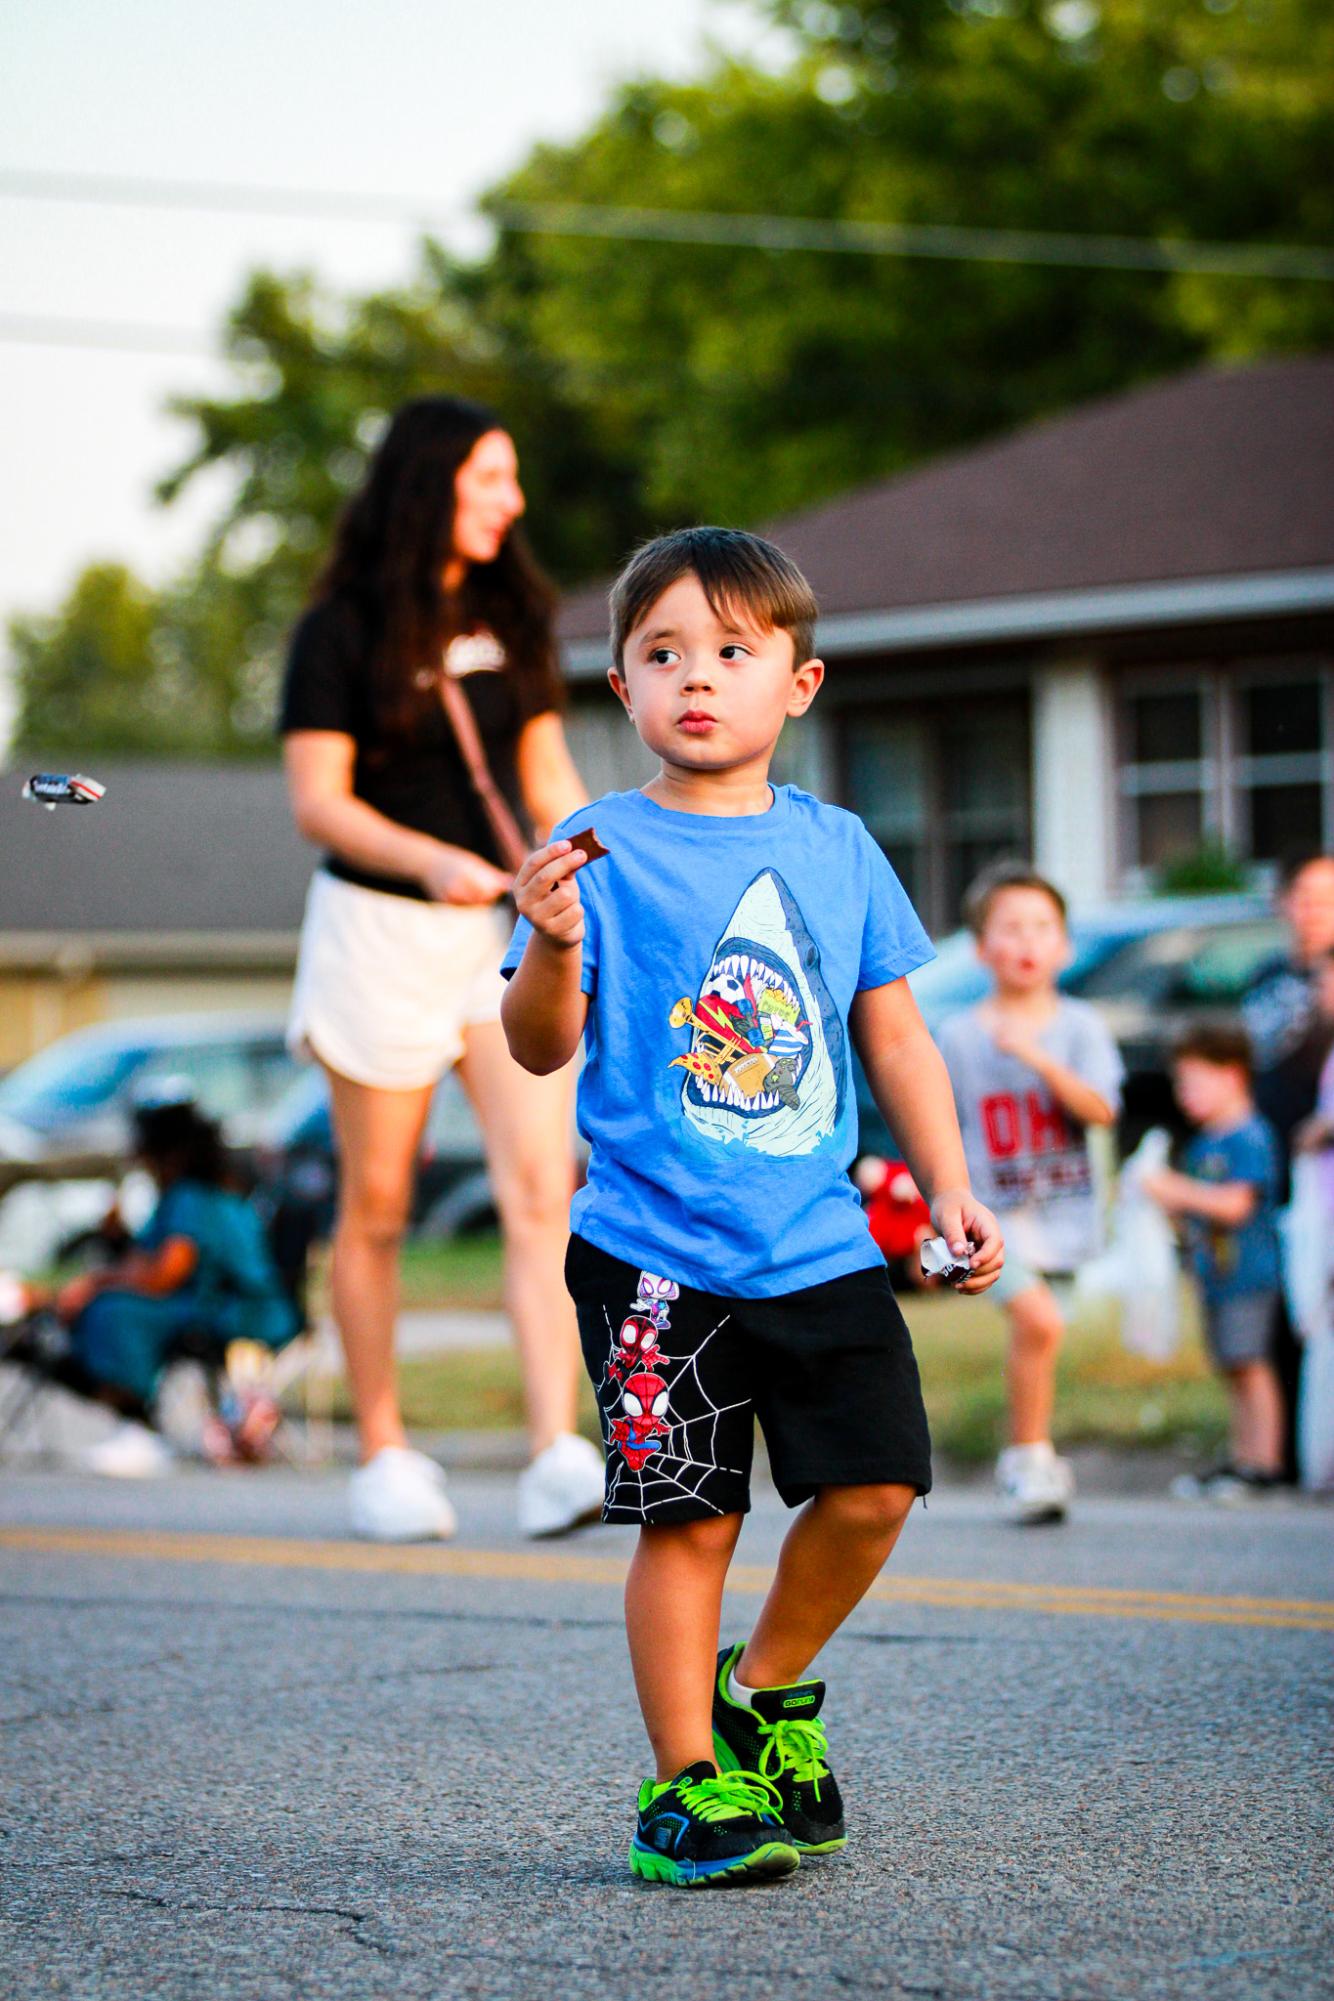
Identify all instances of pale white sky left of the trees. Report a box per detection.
[0,0,772,740]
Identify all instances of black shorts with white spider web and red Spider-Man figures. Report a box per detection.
[566,1237,932,1523]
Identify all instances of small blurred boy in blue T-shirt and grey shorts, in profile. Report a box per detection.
[1144,1023,1284,1501]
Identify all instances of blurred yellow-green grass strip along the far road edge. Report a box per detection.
[326,1237,1226,1463]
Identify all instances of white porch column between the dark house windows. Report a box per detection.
[1032,660,1116,904]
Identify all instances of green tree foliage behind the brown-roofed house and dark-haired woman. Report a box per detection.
[16,0,1334,752]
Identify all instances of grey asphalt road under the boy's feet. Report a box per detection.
[0,1471,1334,2001]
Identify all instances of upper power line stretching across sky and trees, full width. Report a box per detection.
[10,168,1334,284]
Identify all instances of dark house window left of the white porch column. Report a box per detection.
[842,694,1030,932]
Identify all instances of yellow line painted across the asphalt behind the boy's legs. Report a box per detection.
[0,1529,1334,1633]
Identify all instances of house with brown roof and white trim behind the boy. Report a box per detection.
[562,356,1334,930]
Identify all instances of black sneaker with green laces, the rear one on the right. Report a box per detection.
[714,1643,848,1855]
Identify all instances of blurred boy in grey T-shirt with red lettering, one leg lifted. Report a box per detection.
[940,862,1122,1523]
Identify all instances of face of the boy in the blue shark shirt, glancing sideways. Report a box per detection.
[608,576,824,772]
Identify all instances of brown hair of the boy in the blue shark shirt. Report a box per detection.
[610,528,820,668]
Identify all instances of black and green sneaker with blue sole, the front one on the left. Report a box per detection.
[630,1761,800,1889]
